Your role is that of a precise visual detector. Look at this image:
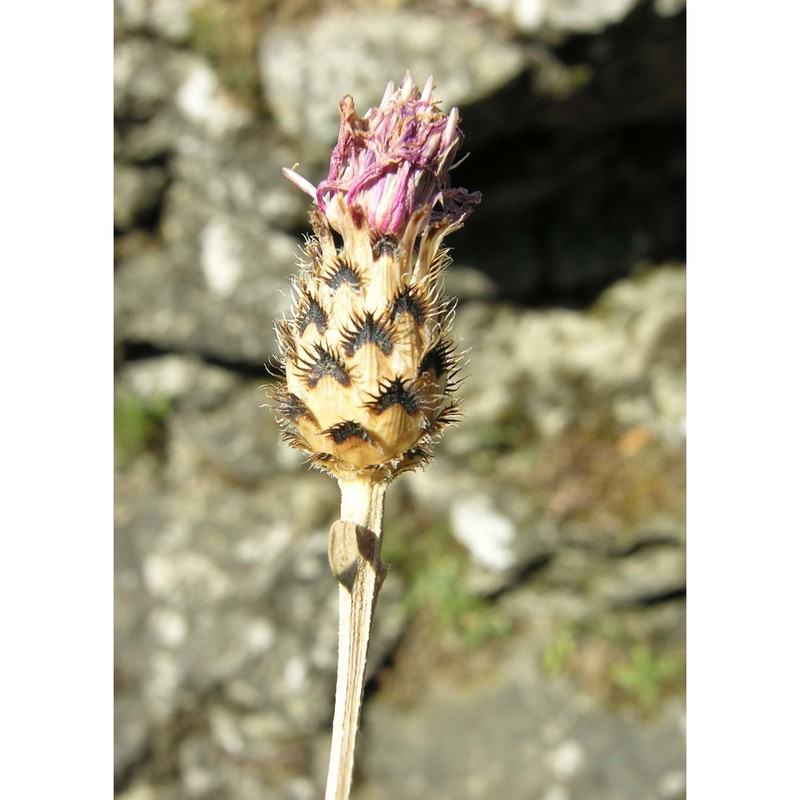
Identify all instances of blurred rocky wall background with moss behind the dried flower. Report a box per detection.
[114,0,685,800]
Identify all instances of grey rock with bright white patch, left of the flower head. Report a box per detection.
[115,184,298,362]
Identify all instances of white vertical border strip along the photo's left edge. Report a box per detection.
[0,2,113,798]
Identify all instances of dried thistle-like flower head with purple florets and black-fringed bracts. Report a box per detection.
[277,76,480,479]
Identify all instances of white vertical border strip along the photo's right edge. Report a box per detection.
[688,0,800,800]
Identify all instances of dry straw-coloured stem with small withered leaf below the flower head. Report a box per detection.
[325,478,386,800]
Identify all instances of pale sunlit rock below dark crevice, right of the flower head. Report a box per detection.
[450,268,686,444]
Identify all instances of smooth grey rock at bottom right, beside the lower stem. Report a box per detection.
[354,641,684,800]
